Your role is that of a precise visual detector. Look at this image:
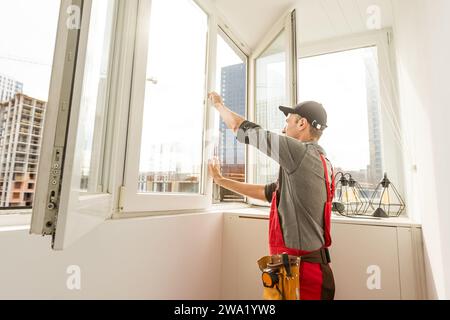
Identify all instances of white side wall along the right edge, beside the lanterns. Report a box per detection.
[392,0,450,299]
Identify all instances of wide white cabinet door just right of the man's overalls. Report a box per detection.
[331,224,401,300]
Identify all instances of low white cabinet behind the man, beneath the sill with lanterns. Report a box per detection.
[222,213,426,300]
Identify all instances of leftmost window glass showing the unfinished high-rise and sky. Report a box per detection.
[0,0,60,210]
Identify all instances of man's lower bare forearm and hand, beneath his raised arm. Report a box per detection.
[209,160,267,201]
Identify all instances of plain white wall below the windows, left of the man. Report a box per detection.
[0,214,223,300]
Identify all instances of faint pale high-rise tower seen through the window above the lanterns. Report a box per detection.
[364,54,383,184]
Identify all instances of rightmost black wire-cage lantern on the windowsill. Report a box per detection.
[366,174,406,218]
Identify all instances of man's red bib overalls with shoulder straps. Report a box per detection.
[269,154,335,300]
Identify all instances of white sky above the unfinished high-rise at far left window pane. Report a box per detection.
[0,0,60,101]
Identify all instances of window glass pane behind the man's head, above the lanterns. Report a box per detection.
[298,47,383,189]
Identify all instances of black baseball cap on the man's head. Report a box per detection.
[280,101,328,131]
